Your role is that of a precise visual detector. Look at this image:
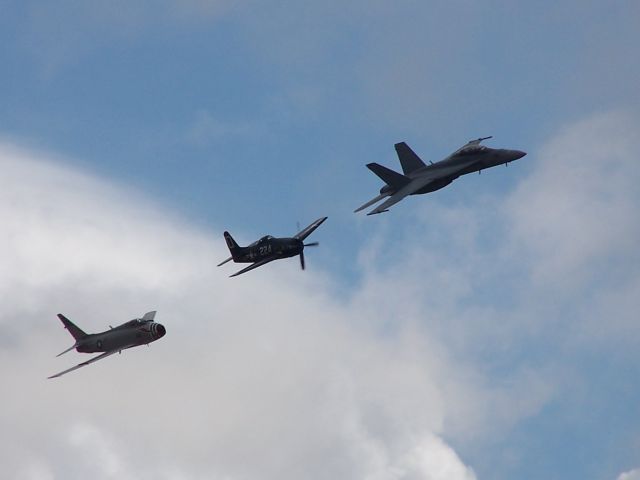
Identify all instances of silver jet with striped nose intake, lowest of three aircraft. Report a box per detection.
[49,312,167,378]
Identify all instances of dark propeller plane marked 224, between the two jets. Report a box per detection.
[218,217,327,277]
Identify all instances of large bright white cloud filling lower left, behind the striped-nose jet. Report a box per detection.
[0,145,484,479]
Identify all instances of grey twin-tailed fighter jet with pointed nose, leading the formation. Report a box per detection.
[355,137,526,215]
